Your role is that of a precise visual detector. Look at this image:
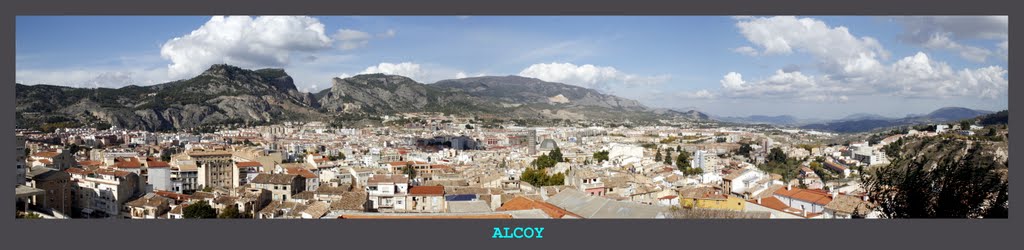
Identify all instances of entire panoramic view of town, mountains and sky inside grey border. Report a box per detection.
[13,16,1010,219]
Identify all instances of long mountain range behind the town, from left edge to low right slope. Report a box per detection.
[15,65,710,130]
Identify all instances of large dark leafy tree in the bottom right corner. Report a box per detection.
[861,138,1009,218]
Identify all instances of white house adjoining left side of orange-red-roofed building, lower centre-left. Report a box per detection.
[366,174,409,210]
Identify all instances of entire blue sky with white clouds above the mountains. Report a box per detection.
[15,15,1010,119]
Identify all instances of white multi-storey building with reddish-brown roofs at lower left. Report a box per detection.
[67,168,140,218]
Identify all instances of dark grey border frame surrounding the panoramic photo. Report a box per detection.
[0,0,1024,249]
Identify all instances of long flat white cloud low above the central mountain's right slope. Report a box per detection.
[519,63,671,90]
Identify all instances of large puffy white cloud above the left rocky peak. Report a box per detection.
[160,16,332,78]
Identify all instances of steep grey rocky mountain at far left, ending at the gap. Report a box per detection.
[15,65,323,130]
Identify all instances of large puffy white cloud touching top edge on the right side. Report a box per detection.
[736,16,889,77]
